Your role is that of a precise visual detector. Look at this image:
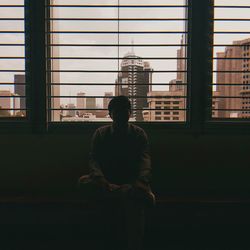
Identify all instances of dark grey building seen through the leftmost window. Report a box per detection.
[14,75,26,114]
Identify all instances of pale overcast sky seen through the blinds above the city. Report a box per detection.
[0,0,250,104]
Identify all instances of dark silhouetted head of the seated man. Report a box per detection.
[108,96,131,126]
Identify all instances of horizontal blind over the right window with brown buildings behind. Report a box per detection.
[211,0,250,120]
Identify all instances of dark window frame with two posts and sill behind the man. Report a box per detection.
[0,0,250,135]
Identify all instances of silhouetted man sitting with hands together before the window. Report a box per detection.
[80,96,154,250]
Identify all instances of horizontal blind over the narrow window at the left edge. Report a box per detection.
[0,0,27,120]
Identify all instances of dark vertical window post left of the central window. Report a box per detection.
[25,0,47,133]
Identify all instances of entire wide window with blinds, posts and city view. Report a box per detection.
[0,0,250,131]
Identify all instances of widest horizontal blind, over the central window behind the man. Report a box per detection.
[47,0,189,122]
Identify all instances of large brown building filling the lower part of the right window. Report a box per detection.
[217,38,250,118]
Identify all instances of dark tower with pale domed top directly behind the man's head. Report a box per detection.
[115,51,153,121]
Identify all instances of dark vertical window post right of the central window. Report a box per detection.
[189,0,212,133]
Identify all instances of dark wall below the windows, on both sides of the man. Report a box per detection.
[0,130,250,195]
